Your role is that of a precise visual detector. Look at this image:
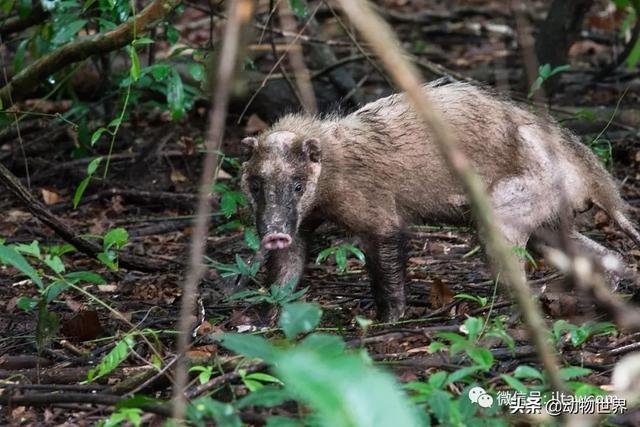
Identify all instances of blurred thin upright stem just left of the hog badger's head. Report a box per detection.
[172,0,254,422]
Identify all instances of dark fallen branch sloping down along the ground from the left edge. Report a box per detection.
[0,163,180,272]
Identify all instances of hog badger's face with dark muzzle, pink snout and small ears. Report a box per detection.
[241,131,321,250]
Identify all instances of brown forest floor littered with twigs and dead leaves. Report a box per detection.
[0,2,640,425]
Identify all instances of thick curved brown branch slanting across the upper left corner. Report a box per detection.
[0,0,181,108]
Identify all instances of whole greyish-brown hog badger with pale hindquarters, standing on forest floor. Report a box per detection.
[241,83,640,320]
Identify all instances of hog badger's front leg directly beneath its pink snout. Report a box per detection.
[265,235,307,286]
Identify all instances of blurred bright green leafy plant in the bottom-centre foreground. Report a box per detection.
[194,303,424,427]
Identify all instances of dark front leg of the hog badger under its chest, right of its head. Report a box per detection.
[364,232,406,322]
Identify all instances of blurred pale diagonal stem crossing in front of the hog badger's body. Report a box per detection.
[338,0,565,390]
